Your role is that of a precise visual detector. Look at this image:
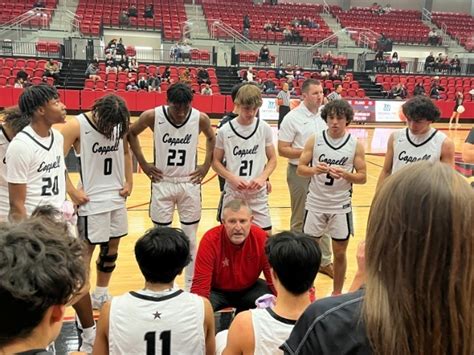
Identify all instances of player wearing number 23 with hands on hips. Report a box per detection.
[129,83,216,291]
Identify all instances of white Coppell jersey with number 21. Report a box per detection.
[217,119,271,190]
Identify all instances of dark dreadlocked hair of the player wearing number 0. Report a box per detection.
[92,94,130,139]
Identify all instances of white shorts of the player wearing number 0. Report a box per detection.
[77,206,128,244]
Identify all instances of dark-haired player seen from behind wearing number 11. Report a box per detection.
[94,227,215,355]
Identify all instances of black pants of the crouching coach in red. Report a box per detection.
[209,279,272,313]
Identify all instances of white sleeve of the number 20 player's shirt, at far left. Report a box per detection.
[5,141,31,184]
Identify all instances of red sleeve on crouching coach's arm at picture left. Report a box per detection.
[191,230,216,299]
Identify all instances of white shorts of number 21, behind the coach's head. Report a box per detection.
[219,188,272,231]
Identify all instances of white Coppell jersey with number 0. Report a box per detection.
[76,114,125,216]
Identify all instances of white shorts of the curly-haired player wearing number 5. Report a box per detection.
[303,210,354,241]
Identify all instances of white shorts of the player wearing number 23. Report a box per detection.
[150,181,201,225]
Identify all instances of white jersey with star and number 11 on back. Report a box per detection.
[109,290,206,355]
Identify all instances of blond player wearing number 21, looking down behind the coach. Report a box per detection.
[213,85,276,232]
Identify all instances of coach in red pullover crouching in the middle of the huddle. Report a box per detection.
[191,200,275,312]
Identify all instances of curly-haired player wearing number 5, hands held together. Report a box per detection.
[297,100,367,295]
